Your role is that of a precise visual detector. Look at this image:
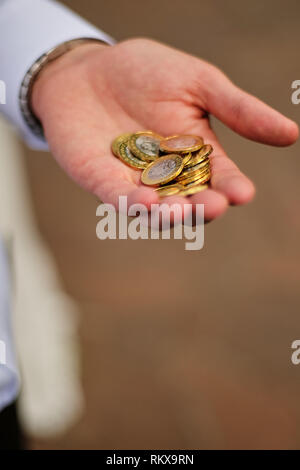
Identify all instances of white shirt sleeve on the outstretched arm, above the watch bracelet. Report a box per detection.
[0,0,114,150]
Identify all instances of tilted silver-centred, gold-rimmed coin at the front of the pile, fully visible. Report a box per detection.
[142,154,183,185]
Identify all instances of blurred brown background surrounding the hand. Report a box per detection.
[26,0,300,449]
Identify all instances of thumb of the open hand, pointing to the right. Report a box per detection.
[201,65,299,146]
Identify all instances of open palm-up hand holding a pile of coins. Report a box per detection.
[32,39,298,220]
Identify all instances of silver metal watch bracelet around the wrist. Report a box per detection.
[19,38,106,138]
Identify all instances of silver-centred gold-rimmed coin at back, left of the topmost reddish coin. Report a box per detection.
[128,131,162,161]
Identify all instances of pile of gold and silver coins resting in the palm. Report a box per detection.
[112,131,213,197]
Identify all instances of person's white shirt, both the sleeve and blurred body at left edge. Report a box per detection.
[0,0,114,411]
